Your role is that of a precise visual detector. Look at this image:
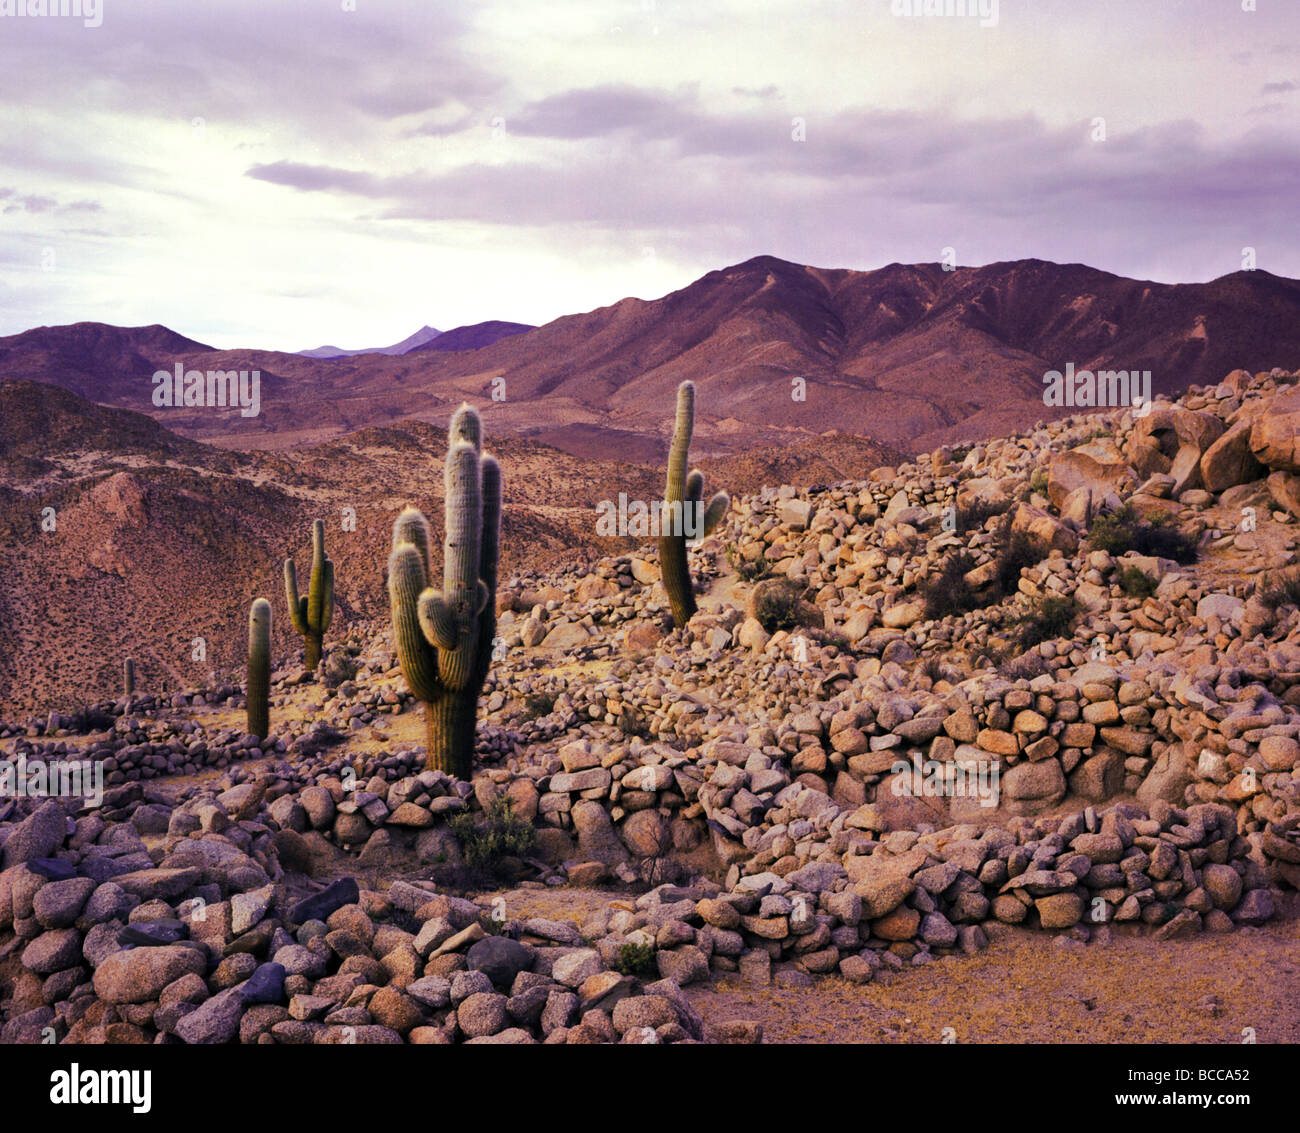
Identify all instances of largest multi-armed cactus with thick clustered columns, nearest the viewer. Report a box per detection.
[389,405,501,780]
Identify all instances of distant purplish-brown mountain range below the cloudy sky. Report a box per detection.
[0,256,1300,459]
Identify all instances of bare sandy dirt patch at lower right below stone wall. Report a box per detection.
[688,895,1300,1043]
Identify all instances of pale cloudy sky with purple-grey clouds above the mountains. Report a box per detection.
[0,0,1300,350]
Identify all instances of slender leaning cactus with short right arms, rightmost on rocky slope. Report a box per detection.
[659,382,731,628]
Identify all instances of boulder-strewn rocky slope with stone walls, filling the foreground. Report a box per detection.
[0,372,1300,1043]
